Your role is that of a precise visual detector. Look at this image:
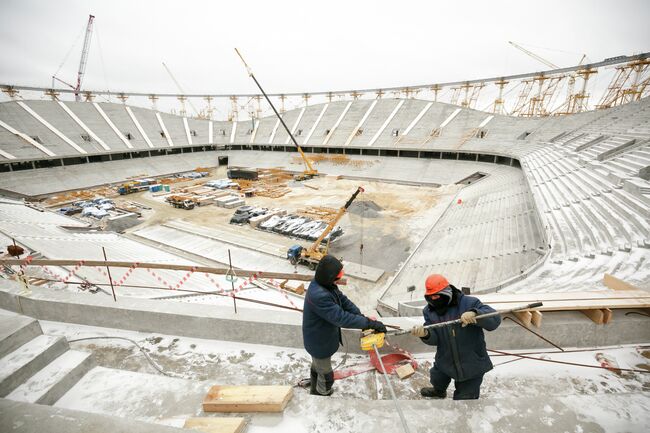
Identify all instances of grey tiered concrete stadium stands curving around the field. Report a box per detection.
[0,98,650,297]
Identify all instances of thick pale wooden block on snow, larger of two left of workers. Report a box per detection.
[203,385,293,412]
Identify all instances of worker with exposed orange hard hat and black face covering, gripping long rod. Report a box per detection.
[411,274,501,400]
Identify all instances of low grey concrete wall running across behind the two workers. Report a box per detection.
[0,281,650,353]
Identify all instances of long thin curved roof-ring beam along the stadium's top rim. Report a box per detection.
[0,52,650,98]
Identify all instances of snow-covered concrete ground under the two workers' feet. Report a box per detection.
[41,322,650,433]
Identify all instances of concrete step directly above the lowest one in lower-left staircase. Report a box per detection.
[0,335,68,397]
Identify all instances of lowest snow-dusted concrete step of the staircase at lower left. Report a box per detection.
[7,350,94,405]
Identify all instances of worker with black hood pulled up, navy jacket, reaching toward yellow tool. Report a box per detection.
[302,255,386,396]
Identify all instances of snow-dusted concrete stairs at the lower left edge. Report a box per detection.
[0,315,93,404]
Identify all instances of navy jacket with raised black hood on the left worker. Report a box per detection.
[302,255,370,358]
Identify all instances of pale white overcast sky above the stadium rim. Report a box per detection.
[0,0,650,93]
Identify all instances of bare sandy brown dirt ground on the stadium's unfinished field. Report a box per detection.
[118,167,458,273]
